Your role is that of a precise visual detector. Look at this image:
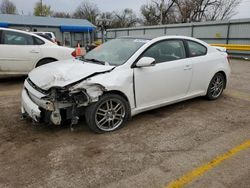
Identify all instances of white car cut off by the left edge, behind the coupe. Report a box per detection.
[0,28,74,77]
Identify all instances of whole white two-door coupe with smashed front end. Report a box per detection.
[22,36,230,133]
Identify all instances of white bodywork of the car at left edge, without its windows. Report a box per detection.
[0,28,74,76]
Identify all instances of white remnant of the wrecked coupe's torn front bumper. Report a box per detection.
[21,89,41,122]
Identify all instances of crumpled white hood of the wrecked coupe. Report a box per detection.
[29,59,114,90]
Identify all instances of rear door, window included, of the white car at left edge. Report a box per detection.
[0,30,41,74]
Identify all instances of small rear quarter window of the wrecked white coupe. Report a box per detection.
[187,41,207,57]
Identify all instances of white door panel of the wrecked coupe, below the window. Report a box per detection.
[134,59,192,108]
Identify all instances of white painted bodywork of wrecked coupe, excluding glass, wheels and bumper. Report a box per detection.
[21,36,230,125]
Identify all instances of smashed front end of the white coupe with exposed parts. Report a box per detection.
[22,78,105,125]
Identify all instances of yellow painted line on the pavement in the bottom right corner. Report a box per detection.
[166,140,250,188]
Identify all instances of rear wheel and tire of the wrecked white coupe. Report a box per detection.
[206,72,226,100]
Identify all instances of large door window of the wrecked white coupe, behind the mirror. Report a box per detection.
[142,40,186,63]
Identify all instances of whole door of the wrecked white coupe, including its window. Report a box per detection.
[134,39,192,108]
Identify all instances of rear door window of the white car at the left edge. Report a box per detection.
[2,31,34,45]
